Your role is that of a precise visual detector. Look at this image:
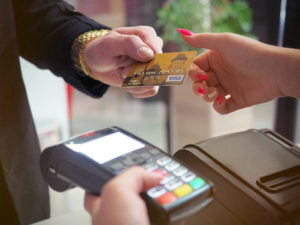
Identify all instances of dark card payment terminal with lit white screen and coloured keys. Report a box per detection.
[40,127,213,224]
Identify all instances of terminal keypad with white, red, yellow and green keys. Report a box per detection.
[109,149,205,205]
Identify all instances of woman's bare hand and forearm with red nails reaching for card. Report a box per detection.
[178,30,300,114]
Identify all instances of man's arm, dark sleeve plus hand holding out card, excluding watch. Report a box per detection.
[14,0,162,98]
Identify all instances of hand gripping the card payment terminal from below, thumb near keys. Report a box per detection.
[84,167,163,225]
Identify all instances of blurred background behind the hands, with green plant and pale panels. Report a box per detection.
[21,0,300,221]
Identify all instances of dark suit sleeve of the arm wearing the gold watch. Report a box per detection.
[13,0,109,97]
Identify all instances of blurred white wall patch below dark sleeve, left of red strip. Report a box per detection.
[21,58,70,148]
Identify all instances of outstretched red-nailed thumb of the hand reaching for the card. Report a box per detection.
[182,33,230,51]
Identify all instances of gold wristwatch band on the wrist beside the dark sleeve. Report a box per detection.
[71,29,110,80]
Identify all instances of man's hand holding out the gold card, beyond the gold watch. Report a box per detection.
[84,26,163,98]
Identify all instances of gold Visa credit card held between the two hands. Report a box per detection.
[122,51,197,87]
